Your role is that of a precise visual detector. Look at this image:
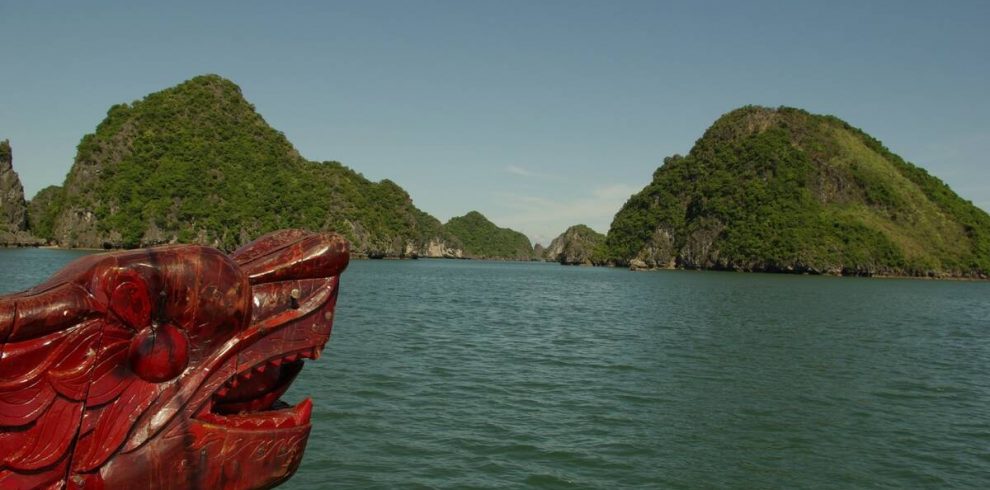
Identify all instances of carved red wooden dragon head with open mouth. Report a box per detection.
[0,230,348,489]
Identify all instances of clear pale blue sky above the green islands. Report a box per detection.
[0,0,990,244]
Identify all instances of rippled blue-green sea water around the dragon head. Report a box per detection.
[0,249,990,489]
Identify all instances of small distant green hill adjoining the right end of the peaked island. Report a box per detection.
[444,211,533,260]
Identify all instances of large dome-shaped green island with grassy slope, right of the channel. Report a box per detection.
[607,107,990,276]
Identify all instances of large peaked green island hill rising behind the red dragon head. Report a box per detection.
[46,75,457,256]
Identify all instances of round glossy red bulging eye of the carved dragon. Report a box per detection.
[128,323,189,383]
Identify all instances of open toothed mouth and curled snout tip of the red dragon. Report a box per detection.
[195,231,347,430]
